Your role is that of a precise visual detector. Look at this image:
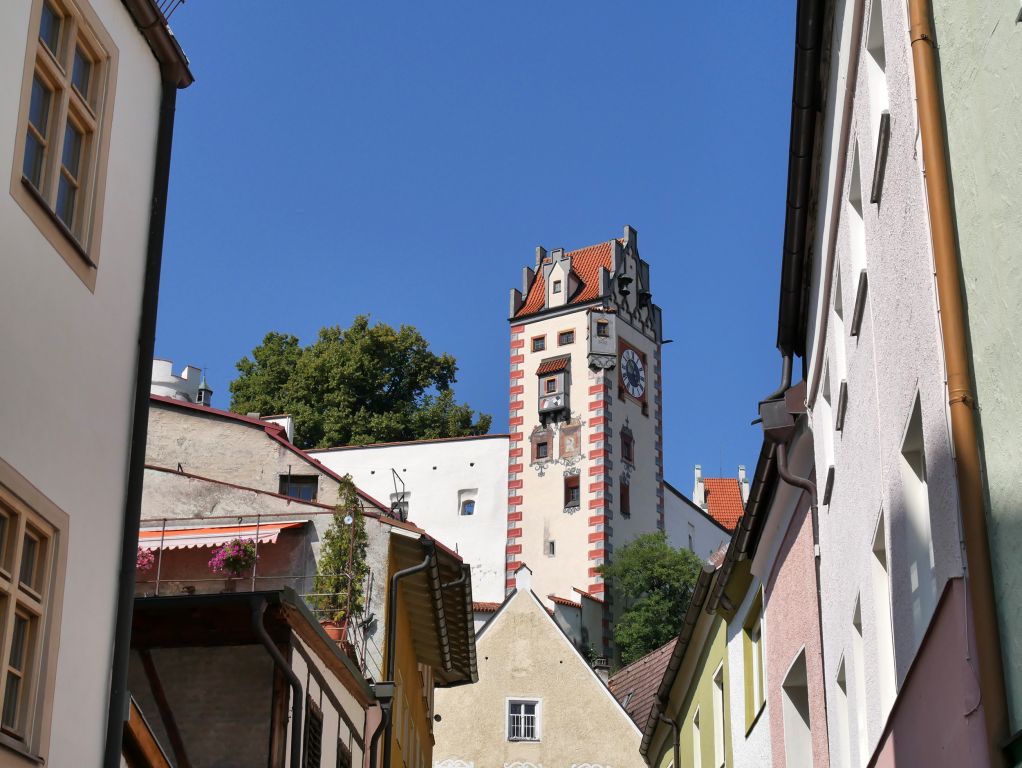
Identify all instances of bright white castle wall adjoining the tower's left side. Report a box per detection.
[312,435,508,602]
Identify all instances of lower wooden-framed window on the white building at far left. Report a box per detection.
[0,486,56,750]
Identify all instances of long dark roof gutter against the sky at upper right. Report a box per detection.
[777,0,824,357]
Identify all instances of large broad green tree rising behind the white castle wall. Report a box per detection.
[231,315,491,448]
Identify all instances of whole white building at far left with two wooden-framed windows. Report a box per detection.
[0,0,192,766]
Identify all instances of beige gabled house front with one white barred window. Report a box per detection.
[433,566,643,768]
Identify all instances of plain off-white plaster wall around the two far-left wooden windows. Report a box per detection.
[0,0,159,766]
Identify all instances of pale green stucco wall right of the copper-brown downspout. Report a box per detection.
[933,0,1022,732]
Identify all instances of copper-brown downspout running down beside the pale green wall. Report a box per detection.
[909,0,1009,766]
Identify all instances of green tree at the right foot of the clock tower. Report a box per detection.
[600,532,702,665]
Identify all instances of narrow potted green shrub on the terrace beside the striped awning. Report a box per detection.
[310,475,369,623]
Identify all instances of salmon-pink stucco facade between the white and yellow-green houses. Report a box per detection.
[768,495,830,768]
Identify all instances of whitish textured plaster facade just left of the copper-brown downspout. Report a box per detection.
[807,0,962,759]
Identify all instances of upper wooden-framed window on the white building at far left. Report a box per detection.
[11,0,117,289]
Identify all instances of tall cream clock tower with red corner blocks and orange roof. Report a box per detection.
[505,227,663,653]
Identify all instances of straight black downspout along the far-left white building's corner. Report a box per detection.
[103,82,178,768]
